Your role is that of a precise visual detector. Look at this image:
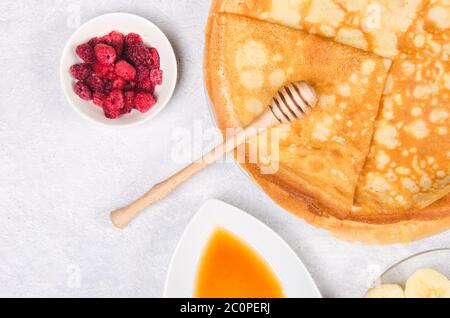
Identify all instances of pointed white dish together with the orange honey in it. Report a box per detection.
[164,200,321,298]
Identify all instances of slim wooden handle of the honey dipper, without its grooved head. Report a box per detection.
[111,111,279,229]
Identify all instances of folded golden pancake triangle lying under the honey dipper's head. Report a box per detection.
[205,13,390,218]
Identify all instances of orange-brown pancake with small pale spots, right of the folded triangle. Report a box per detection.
[354,1,450,221]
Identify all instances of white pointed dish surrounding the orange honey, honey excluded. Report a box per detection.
[164,200,321,298]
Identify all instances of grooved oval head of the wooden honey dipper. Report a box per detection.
[270,81,318,123]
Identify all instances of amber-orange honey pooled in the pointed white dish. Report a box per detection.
[195,228,284,298]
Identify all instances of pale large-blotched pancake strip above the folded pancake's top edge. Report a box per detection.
[213,0,423,58]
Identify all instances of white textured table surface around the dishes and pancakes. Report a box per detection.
[0,0,450,297]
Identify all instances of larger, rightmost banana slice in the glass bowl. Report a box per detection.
[405,268,450,298]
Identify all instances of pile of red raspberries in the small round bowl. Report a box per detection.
[70,31,163,119]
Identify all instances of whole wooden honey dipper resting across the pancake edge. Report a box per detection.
[111,81,317,229]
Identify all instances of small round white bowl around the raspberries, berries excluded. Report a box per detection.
[60,13,177,127]
